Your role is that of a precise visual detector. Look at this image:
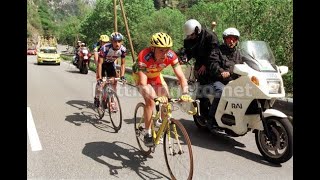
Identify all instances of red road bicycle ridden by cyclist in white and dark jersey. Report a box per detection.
[97,77,125,132]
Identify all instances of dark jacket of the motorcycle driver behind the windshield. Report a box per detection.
[211,44,243,84]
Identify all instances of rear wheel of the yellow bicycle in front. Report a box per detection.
[134,102,151,156]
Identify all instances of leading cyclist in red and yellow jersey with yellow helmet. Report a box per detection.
[132,32,191,146]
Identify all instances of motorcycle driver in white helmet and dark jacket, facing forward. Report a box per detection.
[207,27,243,132]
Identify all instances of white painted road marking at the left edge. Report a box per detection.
[27,107,42,151]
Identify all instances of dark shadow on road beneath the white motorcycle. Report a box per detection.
[180,119,281,167]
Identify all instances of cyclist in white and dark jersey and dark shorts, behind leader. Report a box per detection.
[94,32,127,111]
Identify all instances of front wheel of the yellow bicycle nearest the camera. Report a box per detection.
[163,119,193,180]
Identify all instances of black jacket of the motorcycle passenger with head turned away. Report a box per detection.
[183,29,219,68]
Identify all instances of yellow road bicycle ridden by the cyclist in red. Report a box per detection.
[134,98,199,180]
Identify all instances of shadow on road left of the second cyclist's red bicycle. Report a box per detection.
[65,100,116,133]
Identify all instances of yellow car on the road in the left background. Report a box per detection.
[37,47,61,65]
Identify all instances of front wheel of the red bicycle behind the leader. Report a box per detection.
[107,89,122,132]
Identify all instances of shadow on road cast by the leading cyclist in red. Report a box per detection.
[82,141,170,180]
